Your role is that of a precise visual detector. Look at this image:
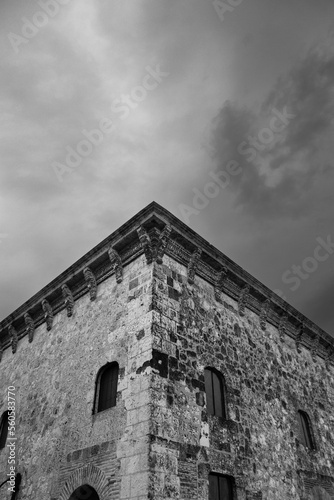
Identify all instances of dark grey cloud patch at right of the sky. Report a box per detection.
[211,33,334,217]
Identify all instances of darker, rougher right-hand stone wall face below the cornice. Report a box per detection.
[150,257,334,500]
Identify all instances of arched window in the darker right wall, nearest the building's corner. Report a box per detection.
[204,368,226,419]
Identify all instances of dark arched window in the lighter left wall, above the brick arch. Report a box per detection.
[94,362,118,413]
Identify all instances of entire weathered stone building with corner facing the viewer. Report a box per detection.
[0,203,334,500]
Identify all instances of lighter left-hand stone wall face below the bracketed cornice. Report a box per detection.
[0,256,152,500]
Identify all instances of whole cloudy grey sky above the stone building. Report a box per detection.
[0,0,334,333]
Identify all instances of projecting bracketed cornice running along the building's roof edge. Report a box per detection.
[0,202,334,366]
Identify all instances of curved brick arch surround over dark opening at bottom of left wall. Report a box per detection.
[58,464,111,500]
